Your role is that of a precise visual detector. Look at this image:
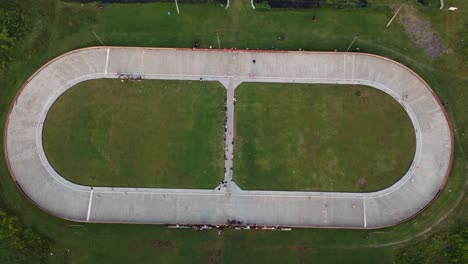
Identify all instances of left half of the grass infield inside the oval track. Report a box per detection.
[43,79,225,188]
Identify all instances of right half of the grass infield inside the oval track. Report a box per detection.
[234,83,415,192]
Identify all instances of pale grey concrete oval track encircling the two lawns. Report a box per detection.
[4,47,453,228]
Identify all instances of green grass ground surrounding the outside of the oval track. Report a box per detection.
[0,0,468,263]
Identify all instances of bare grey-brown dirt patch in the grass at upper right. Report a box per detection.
[399,12,447,59]
